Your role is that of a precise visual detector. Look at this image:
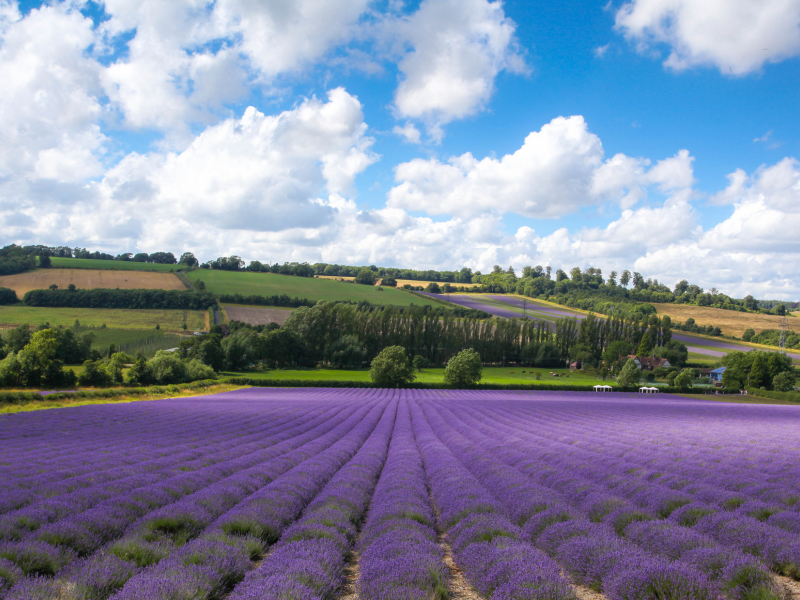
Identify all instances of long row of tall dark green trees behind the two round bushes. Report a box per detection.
[216,302,687,370]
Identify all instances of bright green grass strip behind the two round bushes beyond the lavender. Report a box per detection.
[225,367,616,386]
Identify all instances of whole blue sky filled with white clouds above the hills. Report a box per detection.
[0,0,800,300]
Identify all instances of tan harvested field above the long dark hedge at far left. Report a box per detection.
[0,269,186,300]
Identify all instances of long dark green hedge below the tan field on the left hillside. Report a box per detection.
[22,288,216,310]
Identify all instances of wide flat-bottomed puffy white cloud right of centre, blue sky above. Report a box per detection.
[387,116,694,219]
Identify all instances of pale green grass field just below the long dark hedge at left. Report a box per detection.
[0,304,206,331]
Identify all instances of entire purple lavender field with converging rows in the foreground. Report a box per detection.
[0,389,800,600]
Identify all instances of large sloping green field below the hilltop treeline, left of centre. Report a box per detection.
[186,269,441,306]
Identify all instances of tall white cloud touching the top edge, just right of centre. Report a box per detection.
[391,0,526,139]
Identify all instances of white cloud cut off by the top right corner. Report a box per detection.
[616,0,800,76]
